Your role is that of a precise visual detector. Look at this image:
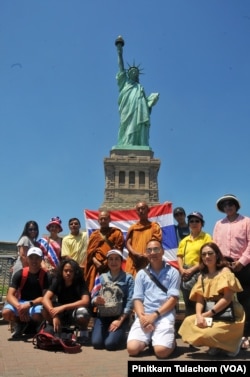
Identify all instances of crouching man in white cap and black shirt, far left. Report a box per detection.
[2,247,49,339]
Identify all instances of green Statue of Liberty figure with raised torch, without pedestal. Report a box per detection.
[115,36,159,147]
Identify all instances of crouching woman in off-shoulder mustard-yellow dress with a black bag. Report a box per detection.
[179,242,245,357]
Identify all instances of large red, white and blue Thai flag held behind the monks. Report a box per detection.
[84,202,178,267]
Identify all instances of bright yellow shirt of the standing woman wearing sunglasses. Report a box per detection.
[177,232,212,266]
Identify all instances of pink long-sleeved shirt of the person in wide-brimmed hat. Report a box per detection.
[213,215,250,266]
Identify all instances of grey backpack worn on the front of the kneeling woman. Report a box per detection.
[97,274,123,317]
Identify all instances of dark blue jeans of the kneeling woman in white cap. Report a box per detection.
[91,317,129,351]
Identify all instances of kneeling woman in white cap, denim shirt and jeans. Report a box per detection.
[92,249,134,351]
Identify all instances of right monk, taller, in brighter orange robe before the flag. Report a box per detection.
[125,202,162,277]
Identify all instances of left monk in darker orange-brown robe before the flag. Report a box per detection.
[84,211,124,292]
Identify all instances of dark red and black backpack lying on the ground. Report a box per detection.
[32,321,82,353]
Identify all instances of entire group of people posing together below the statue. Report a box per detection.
[2,194,250,359]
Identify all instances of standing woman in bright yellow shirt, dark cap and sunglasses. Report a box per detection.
[177,212,212,316]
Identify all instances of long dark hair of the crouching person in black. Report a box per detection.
[56,259,85,294]
